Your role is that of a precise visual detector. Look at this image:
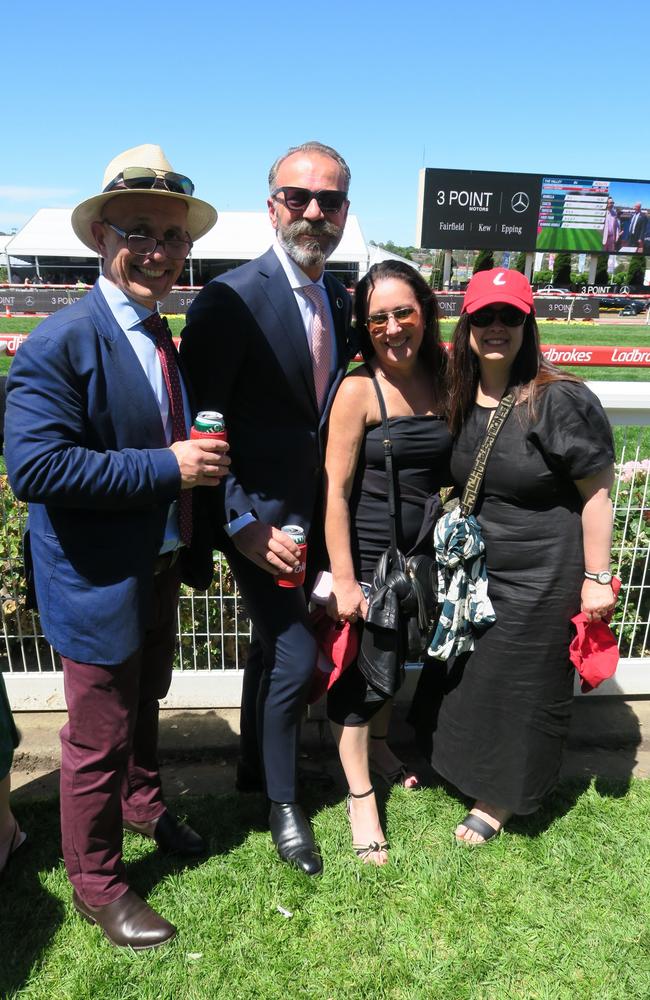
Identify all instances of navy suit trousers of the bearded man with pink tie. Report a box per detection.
[226,545,316,802]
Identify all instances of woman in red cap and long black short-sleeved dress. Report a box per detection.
[414,269,615,845]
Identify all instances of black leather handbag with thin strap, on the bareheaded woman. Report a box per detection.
[357,373,438,697]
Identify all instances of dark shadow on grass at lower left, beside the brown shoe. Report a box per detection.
[0,801,64,997]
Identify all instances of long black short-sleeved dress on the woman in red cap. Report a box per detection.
[411,381,614,814]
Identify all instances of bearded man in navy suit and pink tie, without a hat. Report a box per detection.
[181,142,351,875]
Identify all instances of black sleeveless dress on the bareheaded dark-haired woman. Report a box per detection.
[327,415,451,725]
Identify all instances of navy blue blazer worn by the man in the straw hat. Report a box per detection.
[5,286,211,664]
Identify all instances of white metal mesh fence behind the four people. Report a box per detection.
[0,382,650,711]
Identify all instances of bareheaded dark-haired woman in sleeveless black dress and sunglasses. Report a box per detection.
[325,261,451,865]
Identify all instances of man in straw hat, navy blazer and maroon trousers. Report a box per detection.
[5,145,229,949]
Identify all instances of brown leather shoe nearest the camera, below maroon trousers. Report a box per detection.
[72,889,176,951]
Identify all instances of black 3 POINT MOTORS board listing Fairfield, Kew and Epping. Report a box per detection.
[417,168,540,250]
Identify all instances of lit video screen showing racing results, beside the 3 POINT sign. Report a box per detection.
[536,176,650,253]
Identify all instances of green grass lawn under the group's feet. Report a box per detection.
[0,780,650,1000]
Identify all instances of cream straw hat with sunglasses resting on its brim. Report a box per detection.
[72,143,217,252]
